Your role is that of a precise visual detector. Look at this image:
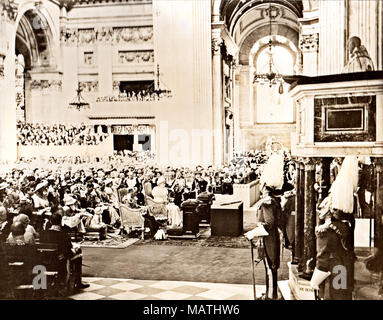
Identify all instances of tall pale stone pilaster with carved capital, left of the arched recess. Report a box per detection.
[212,24,225,165]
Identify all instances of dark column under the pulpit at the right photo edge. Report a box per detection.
[374,158,383,247]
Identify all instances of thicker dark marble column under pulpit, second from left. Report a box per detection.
[303,158,316,274]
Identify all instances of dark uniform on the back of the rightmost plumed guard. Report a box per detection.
[316,220,355,300]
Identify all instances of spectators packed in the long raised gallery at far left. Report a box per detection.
[17,121,108,146]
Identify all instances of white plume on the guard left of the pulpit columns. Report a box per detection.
[260,153,283,189]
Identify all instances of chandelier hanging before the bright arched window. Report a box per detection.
[253,2,283,94]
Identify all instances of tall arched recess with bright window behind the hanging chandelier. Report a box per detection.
[225,0,303,151]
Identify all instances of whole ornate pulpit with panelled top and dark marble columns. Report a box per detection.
[285,71,383,299]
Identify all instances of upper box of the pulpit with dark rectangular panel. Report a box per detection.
[290,71,383,157]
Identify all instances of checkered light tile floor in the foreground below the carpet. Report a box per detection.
[70,278,265,300]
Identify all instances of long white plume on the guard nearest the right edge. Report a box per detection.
[330,156,359,213]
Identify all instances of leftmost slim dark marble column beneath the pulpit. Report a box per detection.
[293,159,305,272]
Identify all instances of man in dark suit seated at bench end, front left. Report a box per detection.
[41,212,89,290]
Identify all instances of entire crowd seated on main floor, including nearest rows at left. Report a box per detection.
[0,148,293,298]
